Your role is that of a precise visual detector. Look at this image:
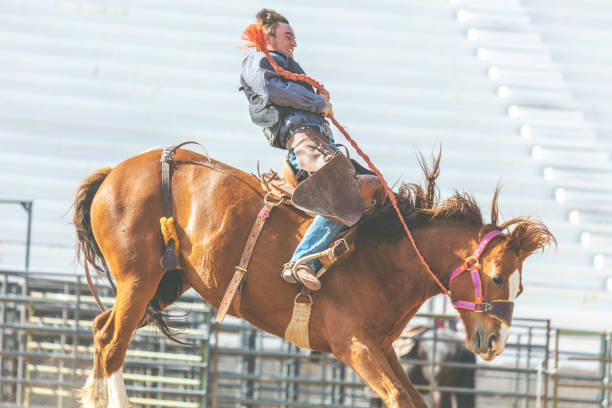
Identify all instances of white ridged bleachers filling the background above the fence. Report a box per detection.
[0,0,612,329]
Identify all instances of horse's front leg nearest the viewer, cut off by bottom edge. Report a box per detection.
[332,335,426,408]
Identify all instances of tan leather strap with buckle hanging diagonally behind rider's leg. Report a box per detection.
[217,195,284,323]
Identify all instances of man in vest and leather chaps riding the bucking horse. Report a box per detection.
[240,8,372,290]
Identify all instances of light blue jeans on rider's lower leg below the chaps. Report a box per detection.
[291,215,346,271]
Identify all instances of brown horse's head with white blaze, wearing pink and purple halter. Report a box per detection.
[450,218,555,361]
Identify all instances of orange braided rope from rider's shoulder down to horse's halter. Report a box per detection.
[241,22,450,296]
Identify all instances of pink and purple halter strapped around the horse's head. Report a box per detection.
[448,231,514,327]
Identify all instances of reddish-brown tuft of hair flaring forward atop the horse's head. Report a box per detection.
[508,218,557,262]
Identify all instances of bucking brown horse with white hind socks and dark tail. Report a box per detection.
[74,149,554,407]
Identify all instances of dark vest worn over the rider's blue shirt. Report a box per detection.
[240,51,314,149]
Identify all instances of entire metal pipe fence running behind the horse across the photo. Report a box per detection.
[0,271,612,408]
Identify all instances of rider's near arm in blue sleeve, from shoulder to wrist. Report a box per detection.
[242,55,326,113]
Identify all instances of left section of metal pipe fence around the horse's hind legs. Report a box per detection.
[0,271,209,408]
